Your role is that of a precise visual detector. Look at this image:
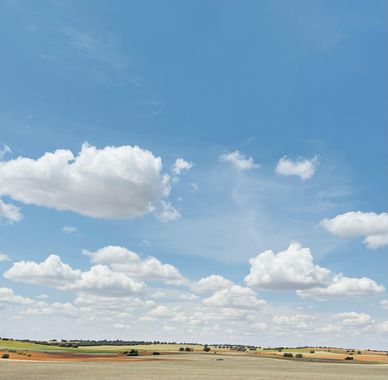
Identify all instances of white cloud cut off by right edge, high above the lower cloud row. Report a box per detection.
[321,211,388,249]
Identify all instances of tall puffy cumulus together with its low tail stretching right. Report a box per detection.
[245,243,384,300]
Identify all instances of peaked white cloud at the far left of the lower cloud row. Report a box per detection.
[4,255,81,287]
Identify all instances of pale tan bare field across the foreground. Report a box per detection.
[0,353,388,380]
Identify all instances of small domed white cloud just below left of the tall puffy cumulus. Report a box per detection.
[203,285,266,309]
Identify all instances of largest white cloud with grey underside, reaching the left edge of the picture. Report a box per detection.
[0,143,170,221]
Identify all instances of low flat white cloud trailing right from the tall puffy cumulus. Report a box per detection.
[297,274,385,300]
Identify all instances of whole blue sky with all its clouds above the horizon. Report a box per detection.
[0,0,388,349]
